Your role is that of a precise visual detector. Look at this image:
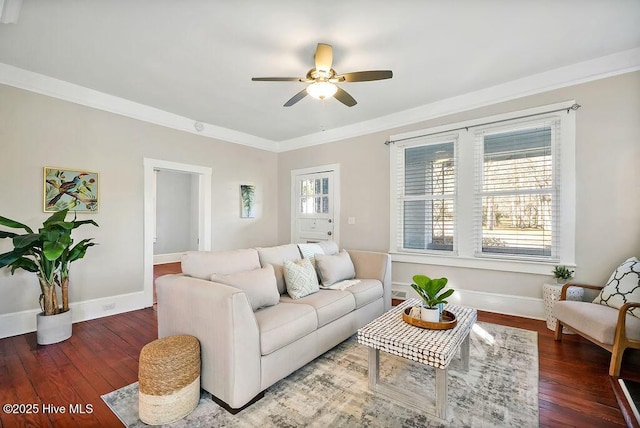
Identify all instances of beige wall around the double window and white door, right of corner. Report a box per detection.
[278,72,640,298]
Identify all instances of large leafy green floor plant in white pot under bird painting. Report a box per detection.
[0,210,98,345]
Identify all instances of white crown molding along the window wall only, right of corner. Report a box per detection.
[278,48,640,152]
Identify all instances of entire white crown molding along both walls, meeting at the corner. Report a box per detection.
[0,48,640,153]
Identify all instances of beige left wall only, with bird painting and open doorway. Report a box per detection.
[0,85,278,315]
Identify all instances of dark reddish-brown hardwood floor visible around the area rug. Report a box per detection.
[0,266,640,428]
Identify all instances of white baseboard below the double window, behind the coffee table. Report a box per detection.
[392,283,546,320]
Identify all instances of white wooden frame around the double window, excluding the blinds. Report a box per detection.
[389,100,576,275]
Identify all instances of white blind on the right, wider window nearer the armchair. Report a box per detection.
[474,120,560,260]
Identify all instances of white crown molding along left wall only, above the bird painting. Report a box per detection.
[0,63,277,151]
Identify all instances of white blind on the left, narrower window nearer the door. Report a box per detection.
[396,139,456,251]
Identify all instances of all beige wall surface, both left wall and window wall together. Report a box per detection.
[0,72,640,315]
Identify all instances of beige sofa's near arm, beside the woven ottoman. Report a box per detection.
[156,275,261,408]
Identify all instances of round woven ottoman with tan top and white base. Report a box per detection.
[138,335,200,425]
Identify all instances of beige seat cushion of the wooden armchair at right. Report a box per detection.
[553,300,640,345]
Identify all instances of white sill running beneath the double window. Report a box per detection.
[390,252,575,276]
